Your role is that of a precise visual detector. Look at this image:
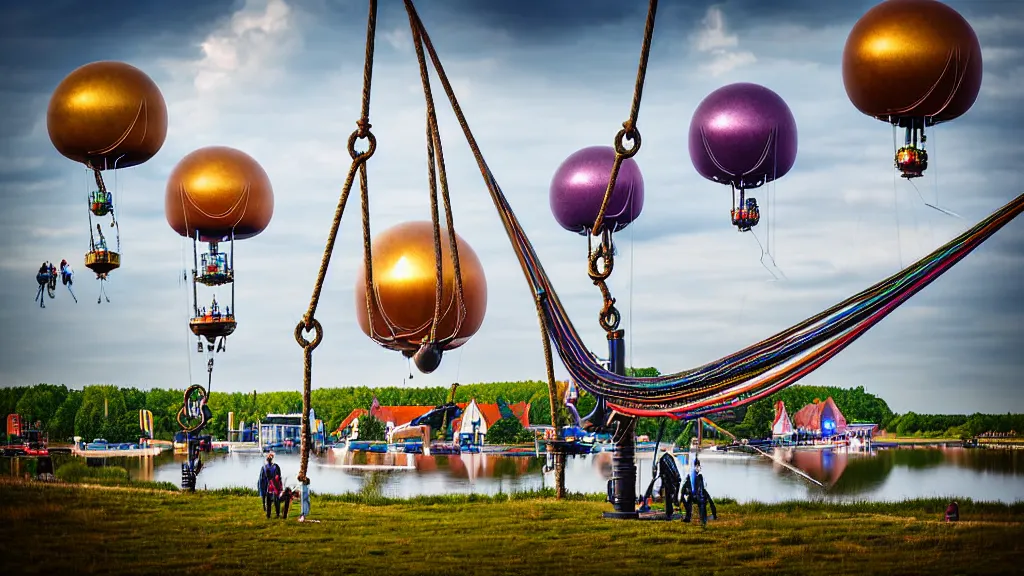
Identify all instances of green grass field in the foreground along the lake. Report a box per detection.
[0,481,1024,576]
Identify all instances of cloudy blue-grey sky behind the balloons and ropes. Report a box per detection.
[0,0,1024,413]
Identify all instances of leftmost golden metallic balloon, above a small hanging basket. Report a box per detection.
[46,61,167,170]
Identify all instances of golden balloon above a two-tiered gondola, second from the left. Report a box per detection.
[165,146,273,241]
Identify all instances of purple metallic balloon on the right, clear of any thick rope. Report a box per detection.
[690,82,797,190]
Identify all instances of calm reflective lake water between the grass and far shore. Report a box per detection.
[44,448,1024,502]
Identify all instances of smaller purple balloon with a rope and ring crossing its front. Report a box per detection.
[550,146,643,235]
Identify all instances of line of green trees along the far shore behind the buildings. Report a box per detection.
[0,377,1024,443]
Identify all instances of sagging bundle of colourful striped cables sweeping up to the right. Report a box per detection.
[484,154,1024,419]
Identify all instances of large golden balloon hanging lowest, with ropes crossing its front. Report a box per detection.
[355,221,487,354]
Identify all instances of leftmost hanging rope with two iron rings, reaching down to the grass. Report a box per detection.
[294,0,377,484]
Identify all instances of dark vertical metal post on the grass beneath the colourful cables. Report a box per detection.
[604,330,639,520]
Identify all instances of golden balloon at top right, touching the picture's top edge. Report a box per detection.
[843,0,982,123]
